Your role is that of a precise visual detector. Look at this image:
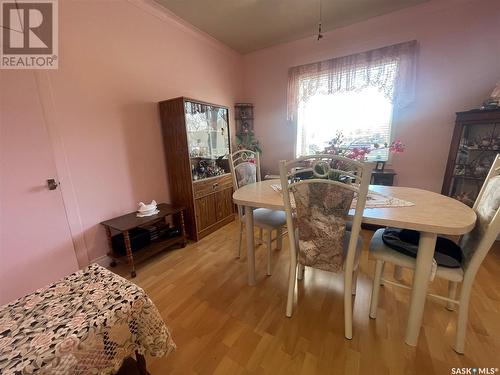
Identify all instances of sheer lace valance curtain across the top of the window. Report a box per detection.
[287,40,417,121]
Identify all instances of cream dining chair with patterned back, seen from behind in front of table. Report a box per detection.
[280,154,373,339]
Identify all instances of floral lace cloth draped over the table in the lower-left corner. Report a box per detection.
[0,264,175,375]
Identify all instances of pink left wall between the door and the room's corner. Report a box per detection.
[2,0,242,274]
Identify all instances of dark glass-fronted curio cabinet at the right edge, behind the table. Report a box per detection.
[441,109,500,206]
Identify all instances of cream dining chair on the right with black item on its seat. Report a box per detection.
[370,154,500,354]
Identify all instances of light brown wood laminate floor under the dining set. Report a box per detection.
[117,222,500,375]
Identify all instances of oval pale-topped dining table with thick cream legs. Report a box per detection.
[233,180,476,346]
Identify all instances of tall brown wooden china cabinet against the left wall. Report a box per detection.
[160,97,234,241]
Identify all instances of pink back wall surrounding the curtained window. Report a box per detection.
[244,0,500,191]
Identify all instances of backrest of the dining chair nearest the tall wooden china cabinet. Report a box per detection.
[229,150,260,219]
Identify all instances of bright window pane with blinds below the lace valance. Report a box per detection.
[296,62,397,161]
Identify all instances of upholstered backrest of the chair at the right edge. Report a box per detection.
[461,154,500,280]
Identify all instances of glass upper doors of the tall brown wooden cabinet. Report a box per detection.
[185,101,230,180]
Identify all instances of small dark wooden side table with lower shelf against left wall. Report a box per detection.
[101,203,187,277]
